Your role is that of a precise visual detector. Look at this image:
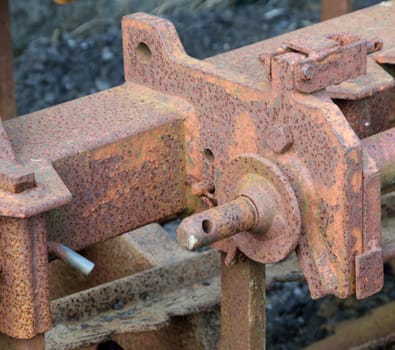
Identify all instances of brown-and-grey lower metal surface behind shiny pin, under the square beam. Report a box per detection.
[49,224,198,300]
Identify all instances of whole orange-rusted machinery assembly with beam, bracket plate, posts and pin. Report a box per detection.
[0,2,395,350]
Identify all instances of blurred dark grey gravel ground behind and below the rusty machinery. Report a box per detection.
[11,0,395,350]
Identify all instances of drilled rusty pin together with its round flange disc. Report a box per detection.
[177,154,301,264]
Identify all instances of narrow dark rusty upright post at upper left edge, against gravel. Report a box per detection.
[0,0,16,120]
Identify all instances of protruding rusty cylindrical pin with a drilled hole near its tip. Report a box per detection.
[177,196,258,250]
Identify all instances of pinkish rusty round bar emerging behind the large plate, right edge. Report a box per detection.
[362,128,395,190]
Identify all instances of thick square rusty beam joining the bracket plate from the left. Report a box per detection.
[5,83,193,250]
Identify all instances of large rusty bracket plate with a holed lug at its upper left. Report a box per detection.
[123,14,368,297]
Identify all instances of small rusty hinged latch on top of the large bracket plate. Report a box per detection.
[259,33,383,93]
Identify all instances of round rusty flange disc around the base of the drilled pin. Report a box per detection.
[215,154,301,264]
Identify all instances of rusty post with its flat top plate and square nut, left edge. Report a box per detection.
[0,161,71,339]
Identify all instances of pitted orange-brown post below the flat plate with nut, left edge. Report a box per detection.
[0,215,51,339]
